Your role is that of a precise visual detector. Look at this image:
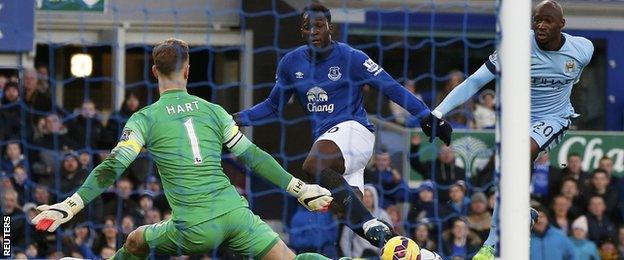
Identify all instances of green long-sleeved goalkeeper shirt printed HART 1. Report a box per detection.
[78,90,292,228]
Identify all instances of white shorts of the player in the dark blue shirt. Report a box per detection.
[315,120,375,192]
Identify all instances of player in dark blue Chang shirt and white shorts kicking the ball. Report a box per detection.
[234,3,452,245]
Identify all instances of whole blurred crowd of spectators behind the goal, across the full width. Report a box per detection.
[0,68,624,259]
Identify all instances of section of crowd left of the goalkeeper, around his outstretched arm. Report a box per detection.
[0,66,166,259]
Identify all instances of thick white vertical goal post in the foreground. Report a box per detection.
[497,0,531,260]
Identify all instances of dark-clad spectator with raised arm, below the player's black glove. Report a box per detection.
[410,135,466,202]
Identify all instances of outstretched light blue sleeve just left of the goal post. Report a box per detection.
[435,64,496,116]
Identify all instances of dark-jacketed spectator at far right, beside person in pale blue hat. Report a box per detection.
[585,196,617,244]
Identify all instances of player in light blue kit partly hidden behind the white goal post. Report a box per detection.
[432,0,594,259]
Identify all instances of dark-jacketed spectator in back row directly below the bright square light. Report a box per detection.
[66,100,106,149]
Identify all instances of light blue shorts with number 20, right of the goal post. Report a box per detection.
[531,117,570,152]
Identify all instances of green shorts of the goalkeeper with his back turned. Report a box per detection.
[143,207,279,259]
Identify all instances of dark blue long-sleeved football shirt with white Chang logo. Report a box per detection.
[240,42,430,139]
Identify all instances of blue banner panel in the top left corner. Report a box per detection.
[0,0,35,52]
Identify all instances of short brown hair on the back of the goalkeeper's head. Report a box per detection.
[152,38,189,76]
